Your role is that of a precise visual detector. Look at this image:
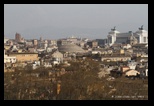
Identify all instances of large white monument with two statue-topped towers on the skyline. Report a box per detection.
[107,25,148,45]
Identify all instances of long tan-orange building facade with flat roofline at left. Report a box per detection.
[8,53,39,62]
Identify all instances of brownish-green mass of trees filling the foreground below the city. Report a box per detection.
[4,58,148,100]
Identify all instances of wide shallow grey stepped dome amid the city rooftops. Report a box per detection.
[58,44,85,52]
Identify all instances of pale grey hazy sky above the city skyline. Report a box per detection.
[4,4,148,39]
